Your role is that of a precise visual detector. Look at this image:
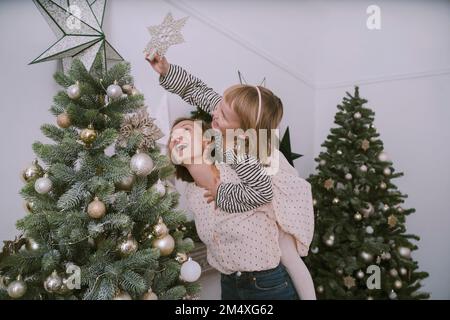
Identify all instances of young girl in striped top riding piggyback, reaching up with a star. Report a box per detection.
[149,56,315,299]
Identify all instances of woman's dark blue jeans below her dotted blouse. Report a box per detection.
[220,263,299,300]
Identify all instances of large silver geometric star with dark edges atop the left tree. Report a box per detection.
[30,0,123,71]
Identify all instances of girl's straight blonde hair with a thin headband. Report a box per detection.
[223,84,283,160]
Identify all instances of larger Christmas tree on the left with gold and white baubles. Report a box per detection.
[0,55,200,299]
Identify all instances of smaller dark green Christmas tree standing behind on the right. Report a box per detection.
[306,87,428,299]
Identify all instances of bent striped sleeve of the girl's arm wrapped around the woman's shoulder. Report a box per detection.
[216,151,273,213]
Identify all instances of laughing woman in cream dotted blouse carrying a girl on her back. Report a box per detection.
[169,119,315,300]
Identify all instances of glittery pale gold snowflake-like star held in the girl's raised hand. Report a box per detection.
[144,12,189,60]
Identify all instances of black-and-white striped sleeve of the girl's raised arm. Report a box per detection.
[159,64,222,114]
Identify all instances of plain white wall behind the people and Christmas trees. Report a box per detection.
[0,0,450,299]
